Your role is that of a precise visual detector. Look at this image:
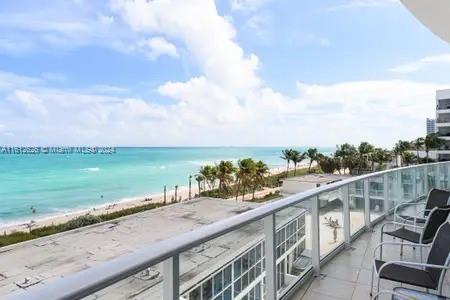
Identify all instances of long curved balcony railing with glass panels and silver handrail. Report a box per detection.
[7,162,450,300]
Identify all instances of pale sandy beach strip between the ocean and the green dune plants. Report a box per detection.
[0,166,294,234]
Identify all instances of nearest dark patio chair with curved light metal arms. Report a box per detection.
[370,221,450,297]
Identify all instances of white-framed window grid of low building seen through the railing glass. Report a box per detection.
[181,211,310,300]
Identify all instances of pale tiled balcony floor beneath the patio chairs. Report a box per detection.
[290,219,450,300]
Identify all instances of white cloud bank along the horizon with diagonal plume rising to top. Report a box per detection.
[0,0,440,146]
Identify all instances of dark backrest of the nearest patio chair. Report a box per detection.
[426,222,450,284]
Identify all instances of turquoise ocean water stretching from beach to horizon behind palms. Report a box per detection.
[0,147,334,226]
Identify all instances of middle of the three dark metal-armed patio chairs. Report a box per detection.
[380,205,450,262]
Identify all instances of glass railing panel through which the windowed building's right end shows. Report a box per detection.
[272,201,312,299]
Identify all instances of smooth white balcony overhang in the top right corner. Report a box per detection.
[401,0,450,43]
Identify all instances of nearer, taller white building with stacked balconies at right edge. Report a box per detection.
[436,89,450,160]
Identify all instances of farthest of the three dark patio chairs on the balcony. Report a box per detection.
[394,188,450,225]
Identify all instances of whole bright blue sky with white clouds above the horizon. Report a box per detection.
[0,0,450,146]
